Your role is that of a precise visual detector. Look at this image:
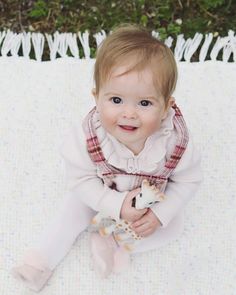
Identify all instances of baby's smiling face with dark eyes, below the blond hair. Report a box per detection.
[95,66,170,154]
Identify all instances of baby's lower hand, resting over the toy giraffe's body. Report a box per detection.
[131,209,161,237]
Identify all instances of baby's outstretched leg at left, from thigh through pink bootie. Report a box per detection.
[13,192,96,291]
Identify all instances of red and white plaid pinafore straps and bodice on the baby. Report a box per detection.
[83,104,189,192]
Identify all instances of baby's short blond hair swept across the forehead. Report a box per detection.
[94,25,177,103]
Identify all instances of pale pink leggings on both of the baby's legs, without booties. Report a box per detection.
[30,192,183,270]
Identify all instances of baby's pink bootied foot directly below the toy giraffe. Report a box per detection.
[90,233,117,278]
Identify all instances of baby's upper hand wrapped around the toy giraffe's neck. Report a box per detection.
[120,188,148,222]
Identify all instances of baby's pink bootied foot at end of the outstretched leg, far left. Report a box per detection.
[12,251,52,292]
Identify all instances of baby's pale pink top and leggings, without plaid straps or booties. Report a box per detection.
[12,104,202,292]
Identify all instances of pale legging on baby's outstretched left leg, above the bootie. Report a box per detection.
[36,193,96,269]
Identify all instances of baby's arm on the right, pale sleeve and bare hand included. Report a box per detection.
[131,135,202,237]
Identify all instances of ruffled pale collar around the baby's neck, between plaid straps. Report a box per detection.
[93,108,175,173]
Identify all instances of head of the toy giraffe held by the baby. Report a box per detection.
[135,179,165,209]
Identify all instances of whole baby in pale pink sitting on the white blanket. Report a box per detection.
[13,26,202,291]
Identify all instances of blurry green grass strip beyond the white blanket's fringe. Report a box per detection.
[0,0,236,56]
